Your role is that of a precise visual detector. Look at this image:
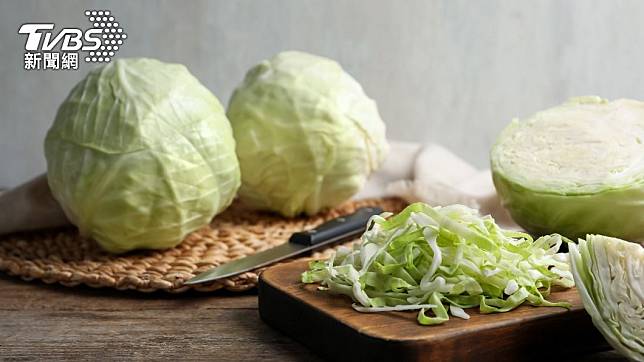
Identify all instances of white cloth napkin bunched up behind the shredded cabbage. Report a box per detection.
[355,141,518,228]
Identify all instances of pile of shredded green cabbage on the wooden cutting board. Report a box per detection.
[302,203,574,325]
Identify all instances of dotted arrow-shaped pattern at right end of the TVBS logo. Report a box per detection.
[85,10,127,63]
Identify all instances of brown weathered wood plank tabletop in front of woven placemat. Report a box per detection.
[0,273,621,361]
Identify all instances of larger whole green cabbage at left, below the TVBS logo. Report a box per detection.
[45,59,240,252]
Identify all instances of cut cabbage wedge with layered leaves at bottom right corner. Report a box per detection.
[570,235,644,361]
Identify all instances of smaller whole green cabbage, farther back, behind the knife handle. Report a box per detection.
[227,51,388,216]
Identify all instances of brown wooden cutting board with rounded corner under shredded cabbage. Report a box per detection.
[259,261,609,361]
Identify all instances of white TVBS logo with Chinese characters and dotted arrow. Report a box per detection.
[18,10,127,70]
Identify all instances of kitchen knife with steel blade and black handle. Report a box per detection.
[185,207,382,285]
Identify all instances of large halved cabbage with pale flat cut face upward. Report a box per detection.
[491,97,644,240]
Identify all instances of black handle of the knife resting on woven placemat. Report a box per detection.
[289,207,382,245]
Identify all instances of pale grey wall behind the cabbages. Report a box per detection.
[0,0,644,186]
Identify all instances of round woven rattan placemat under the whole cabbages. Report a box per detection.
[0,198,405,293]
